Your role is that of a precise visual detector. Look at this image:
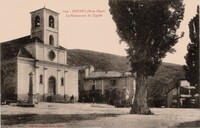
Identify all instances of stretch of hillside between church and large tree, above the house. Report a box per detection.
[67,49,131,72]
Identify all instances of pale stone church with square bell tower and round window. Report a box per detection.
[0,7,78,102]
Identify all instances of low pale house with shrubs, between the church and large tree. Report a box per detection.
[79,66,136,105]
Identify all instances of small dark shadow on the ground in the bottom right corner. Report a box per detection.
[176,120,200,128]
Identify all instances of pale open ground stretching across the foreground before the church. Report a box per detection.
[1,103,200,128]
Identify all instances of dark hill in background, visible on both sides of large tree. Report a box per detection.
[68,49,185,106]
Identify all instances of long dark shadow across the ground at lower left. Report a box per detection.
[1,114,120,125]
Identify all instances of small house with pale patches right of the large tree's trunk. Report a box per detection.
[167,80,198,107]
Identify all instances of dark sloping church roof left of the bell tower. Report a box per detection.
[0,35,43,60]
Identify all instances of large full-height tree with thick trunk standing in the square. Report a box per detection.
[109,0,184,114]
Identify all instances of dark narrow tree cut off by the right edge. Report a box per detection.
[184,7,199,85]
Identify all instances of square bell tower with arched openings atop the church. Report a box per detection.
[31,7,59,47]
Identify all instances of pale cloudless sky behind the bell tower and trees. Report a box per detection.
[0,0,200,64]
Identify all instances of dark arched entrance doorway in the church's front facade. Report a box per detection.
[48,76,56,102]
